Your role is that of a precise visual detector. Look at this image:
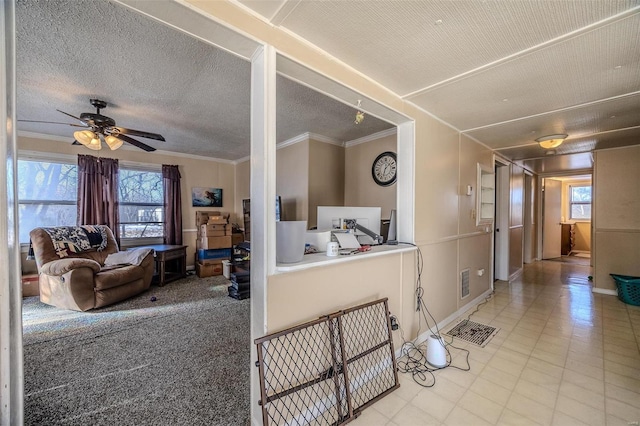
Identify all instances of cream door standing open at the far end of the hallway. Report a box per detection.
[542,179,562,259]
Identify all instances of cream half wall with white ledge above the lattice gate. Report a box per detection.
[265,244,417,340]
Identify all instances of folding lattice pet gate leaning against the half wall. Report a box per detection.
[255,298,399,426]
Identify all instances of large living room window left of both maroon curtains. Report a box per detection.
[18,160,78,244]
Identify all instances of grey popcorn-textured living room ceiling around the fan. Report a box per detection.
[16,0,392,160]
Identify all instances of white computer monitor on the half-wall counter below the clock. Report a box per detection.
[317,206,382,238]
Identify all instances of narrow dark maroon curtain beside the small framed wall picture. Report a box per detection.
[162,164,182,245]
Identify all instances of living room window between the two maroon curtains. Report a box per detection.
[118,167,164,239]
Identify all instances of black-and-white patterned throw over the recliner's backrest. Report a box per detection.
[43,225,107,257]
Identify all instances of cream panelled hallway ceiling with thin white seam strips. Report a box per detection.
[239,0,640,173]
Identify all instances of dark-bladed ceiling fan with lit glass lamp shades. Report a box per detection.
[19,99,164,152]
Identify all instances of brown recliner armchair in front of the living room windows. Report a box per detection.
[29,225,154,311]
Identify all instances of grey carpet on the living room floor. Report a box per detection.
[23,276,249,425]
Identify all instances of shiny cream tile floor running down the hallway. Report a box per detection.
[351,261,640,426]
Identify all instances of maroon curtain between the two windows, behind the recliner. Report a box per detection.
[78,155,120,246]
